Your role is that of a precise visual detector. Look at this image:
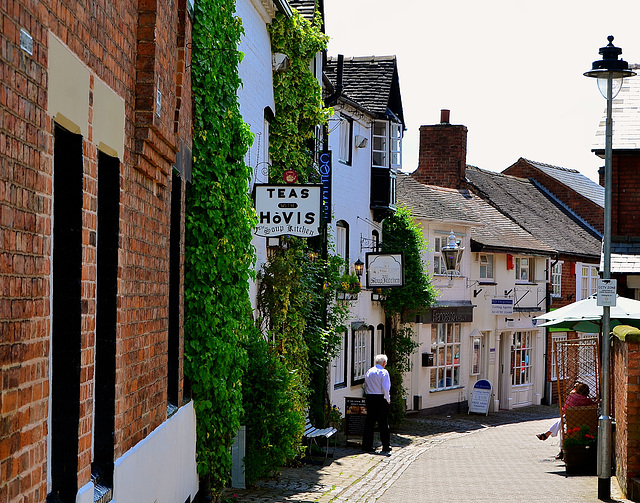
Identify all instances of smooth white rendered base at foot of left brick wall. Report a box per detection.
[112,402,198,503]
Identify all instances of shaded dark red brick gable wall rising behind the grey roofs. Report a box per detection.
[503,158,604,232]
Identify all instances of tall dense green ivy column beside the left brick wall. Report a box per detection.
[184,0,256,492]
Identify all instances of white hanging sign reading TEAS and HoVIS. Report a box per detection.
[254,185,322,238]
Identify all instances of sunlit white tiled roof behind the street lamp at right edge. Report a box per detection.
[593,64,640,150]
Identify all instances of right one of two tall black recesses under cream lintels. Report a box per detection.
[91,152,120,491]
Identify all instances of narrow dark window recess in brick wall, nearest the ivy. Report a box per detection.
[167,171,182,413]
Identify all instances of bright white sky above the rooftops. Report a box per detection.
[325,0,640,181]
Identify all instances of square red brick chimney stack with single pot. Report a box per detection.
[411,110,467,189]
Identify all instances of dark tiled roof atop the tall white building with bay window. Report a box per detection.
[325,56,404,123]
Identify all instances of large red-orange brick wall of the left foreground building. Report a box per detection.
[0,0,191,503]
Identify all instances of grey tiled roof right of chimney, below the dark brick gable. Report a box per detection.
[466,166,601,257]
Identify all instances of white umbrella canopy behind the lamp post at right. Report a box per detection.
[534,295,640,334]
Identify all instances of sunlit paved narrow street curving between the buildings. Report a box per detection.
[224,406,627,503]
